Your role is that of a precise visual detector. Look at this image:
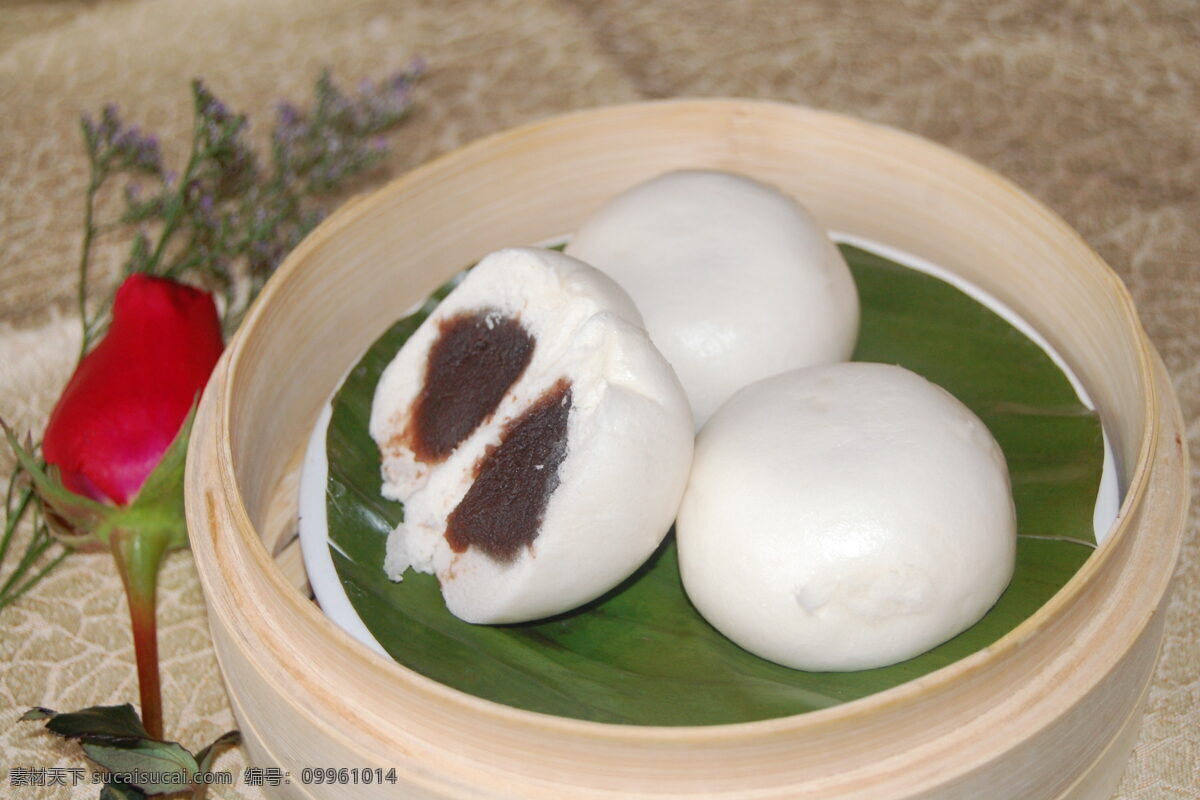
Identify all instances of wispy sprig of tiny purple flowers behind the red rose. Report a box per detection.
[0,61,425,609]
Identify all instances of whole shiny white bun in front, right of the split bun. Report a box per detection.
[676,363,1016,670]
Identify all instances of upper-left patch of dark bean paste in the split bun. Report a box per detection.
[408,309,534,463]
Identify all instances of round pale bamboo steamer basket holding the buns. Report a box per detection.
[187,100,1188,800]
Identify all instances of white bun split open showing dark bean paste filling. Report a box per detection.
[370,248,694,622]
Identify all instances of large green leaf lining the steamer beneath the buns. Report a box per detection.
[326,247,1103,726]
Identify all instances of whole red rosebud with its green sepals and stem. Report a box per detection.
[5,273,223,739]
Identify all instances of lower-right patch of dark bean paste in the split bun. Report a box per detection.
[445,379,571,564]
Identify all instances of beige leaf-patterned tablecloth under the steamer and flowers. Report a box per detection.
[0,0,1200,800]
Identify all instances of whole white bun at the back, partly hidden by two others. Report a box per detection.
[566,169,858,426]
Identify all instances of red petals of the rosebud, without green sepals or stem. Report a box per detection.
[42,275,224,505]
